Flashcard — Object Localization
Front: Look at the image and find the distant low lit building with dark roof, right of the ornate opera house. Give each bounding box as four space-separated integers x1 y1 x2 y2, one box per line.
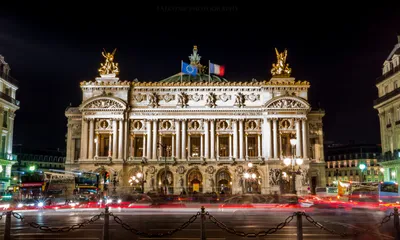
325 144 383 186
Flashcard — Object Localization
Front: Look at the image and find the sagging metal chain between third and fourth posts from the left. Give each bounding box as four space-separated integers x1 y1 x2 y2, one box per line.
206 212 297 237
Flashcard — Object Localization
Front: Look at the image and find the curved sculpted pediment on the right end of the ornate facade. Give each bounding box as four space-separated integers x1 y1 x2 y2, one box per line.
264 96 310 110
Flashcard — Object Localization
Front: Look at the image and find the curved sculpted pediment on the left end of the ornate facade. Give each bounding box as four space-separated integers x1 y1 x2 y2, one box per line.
80 97 126 111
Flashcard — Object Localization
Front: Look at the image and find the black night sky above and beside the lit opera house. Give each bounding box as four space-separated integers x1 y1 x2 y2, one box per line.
0 1 400 149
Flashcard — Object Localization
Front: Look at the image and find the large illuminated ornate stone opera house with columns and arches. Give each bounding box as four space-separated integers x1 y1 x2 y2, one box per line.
65 47 326 194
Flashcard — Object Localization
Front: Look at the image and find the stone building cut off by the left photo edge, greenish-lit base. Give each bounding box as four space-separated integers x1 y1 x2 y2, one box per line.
0 55 19 193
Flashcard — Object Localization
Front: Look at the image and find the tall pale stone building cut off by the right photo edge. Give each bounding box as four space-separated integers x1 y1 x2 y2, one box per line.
374 36 400 182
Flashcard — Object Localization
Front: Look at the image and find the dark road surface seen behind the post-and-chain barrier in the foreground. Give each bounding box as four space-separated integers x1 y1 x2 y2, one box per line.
0 208 394 240
